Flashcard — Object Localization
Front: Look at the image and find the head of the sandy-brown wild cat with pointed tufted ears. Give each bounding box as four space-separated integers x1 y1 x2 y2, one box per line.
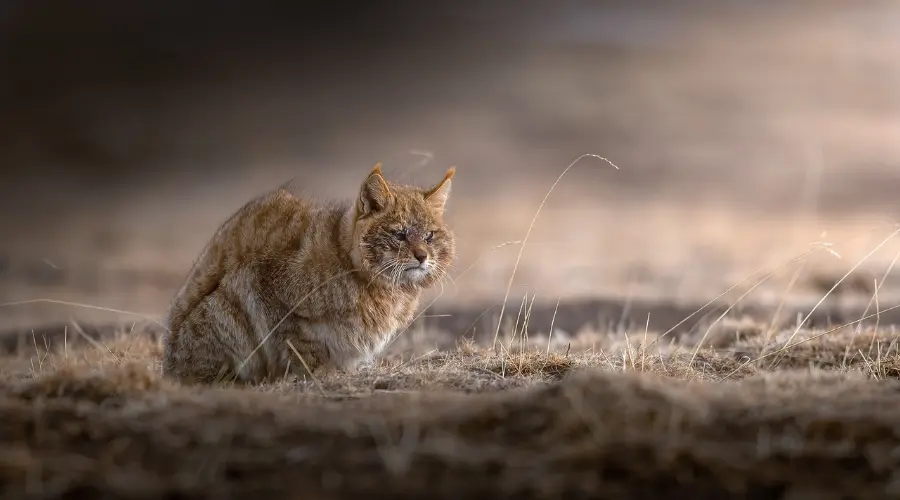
353 163 456 288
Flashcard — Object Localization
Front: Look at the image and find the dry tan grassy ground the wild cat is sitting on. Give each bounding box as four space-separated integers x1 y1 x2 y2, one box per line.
0 318 900 498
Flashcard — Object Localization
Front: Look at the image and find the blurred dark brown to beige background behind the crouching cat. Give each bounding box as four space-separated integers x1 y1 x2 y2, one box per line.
0 0 900 336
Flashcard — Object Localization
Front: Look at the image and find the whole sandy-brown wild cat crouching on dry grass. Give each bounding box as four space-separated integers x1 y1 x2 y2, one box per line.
162 163 455 384
